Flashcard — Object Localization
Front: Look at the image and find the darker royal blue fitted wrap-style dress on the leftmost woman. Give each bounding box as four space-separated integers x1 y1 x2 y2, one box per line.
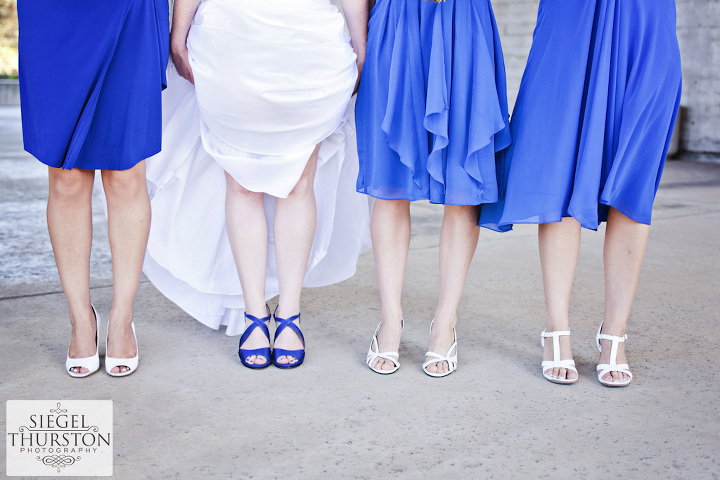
17 0 170 170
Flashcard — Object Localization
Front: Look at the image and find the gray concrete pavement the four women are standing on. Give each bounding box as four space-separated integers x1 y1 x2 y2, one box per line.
0 103 720 479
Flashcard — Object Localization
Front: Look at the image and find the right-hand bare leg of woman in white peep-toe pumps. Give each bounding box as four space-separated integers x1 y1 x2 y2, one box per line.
102 161 150 373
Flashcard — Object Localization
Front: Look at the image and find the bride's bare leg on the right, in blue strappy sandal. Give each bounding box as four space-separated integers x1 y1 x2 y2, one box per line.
274 144 320 364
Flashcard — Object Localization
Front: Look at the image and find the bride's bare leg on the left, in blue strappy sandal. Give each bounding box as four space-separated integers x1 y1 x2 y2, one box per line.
225 172 270 365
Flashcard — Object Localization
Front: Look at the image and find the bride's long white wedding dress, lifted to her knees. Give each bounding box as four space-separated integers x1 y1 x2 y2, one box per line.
143 0 370 335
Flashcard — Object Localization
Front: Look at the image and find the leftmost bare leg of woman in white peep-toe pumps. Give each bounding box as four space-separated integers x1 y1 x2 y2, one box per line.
47 167 96 373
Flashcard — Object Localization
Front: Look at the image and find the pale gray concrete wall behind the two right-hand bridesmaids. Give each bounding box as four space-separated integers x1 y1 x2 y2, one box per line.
493 0 720 155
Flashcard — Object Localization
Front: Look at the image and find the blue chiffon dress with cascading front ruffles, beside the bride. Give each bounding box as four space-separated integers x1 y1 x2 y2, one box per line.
356 0 510 205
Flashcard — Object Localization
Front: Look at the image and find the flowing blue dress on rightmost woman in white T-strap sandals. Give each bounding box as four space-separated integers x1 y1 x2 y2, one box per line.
480 0 682 231
